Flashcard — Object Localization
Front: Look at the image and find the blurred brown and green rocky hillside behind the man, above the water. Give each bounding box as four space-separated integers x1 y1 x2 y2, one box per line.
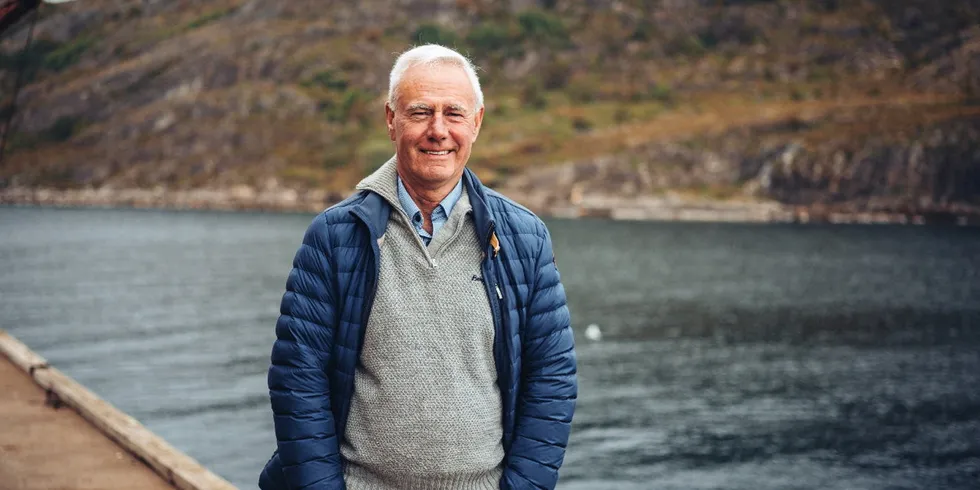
0 0 980 219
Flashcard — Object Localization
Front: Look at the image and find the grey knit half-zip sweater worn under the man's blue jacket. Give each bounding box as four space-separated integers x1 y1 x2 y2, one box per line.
341 160 504 490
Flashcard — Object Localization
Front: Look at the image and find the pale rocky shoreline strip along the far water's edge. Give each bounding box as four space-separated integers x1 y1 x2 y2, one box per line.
0 188 980 227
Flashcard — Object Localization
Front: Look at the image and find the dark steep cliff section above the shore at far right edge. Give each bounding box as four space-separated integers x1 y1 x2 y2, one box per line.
745 116 980 211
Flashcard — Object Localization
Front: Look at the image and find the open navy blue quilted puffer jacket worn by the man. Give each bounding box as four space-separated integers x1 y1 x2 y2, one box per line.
259 169 578 490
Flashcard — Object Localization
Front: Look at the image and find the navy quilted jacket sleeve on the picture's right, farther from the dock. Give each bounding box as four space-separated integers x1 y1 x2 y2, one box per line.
500 224 578 490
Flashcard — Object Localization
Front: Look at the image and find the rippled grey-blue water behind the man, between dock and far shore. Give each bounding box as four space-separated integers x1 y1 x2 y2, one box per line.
0 208 980 490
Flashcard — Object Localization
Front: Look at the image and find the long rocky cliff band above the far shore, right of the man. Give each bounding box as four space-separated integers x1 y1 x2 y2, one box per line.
506 112 980 215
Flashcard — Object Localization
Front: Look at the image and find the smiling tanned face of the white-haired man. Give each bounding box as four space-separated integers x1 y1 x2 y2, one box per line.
385 64 483 186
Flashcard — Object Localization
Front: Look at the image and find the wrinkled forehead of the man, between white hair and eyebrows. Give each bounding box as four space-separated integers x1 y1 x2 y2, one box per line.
395 62 477 111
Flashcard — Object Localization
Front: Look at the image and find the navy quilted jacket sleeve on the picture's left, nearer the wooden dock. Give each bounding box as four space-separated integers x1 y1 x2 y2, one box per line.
268 215 344 490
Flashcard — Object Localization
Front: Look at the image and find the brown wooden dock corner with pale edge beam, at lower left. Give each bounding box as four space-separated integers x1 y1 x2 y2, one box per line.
0 330 235 490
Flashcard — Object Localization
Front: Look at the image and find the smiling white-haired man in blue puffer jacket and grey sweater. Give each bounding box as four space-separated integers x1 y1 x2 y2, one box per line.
259 45 577 490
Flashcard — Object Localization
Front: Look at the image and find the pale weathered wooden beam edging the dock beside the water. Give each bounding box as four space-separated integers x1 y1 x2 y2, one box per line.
0 330 235 490
